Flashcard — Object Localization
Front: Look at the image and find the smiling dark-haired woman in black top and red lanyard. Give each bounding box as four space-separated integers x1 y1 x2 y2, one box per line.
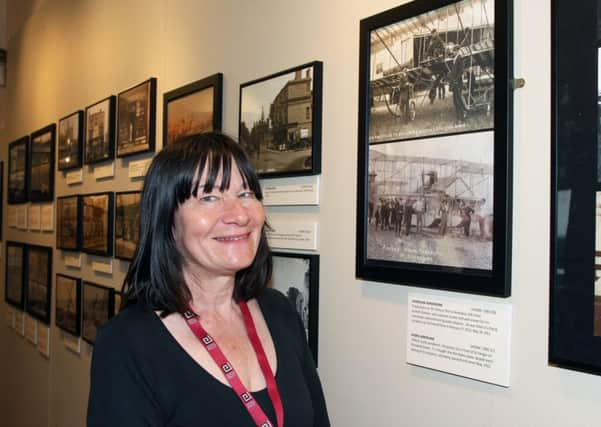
88 133 330 427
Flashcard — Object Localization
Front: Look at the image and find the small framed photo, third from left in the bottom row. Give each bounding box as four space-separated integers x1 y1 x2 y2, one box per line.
54 274 81 337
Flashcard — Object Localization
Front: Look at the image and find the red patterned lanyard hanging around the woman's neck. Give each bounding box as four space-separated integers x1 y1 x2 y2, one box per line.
184 301 284 427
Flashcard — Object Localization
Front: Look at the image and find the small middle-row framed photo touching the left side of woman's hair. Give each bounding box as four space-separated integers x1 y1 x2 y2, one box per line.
115 191 142 260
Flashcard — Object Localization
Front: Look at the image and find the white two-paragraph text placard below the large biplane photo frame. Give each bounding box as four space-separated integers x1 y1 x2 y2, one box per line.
407 293 511 387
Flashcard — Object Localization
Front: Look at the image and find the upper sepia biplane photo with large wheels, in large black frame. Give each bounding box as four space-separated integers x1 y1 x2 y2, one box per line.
369 0 495 143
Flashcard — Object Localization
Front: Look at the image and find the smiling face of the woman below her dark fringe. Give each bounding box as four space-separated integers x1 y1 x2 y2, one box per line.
173 162 265 279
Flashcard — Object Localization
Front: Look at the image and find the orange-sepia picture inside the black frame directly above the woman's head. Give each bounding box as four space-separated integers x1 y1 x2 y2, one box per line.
167 86 214 144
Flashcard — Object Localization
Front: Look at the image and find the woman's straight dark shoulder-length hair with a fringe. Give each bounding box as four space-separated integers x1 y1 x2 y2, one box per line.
123 132 272 316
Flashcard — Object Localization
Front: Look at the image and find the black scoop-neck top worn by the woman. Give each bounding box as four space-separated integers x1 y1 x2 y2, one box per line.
87 289 330 427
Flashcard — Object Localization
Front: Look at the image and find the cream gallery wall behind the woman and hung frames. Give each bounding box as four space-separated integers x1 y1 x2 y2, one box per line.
0 0 601 427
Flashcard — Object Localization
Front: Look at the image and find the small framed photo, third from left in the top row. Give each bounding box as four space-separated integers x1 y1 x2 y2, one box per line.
57 110 84 171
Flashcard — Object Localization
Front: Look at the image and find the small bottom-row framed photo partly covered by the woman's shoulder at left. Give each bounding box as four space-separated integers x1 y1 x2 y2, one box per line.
81 281 115 344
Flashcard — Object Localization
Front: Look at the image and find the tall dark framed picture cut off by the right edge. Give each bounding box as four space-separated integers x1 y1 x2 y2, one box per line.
549 0 601 375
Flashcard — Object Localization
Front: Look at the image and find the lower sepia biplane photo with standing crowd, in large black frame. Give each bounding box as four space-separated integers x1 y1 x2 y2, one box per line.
367 132 494 270
